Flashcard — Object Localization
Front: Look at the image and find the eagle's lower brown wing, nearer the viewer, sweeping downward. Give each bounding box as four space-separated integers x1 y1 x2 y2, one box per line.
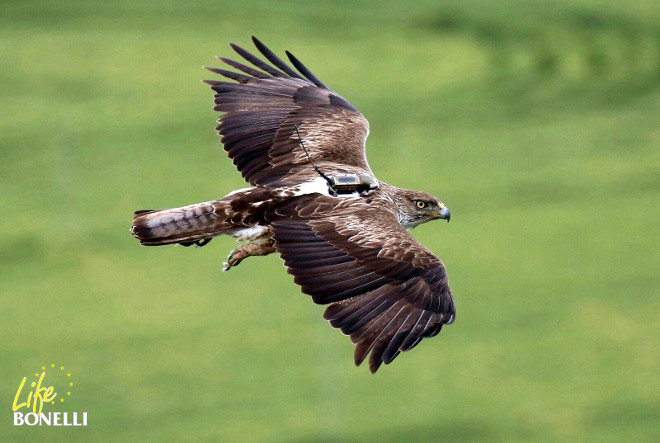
267 194 455 372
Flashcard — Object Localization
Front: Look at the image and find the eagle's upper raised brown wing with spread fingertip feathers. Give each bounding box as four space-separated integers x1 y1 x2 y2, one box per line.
205 37 371 186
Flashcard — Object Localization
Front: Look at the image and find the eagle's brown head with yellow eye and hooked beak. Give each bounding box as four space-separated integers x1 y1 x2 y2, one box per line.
394 189 449 229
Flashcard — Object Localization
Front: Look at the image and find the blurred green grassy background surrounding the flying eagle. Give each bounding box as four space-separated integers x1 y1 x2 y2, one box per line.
0 0 660 442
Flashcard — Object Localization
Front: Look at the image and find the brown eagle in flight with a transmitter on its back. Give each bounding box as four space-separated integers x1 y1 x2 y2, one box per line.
131 37 455 373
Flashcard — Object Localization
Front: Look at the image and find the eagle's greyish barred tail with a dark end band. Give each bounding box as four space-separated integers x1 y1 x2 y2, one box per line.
131 200 232 246
